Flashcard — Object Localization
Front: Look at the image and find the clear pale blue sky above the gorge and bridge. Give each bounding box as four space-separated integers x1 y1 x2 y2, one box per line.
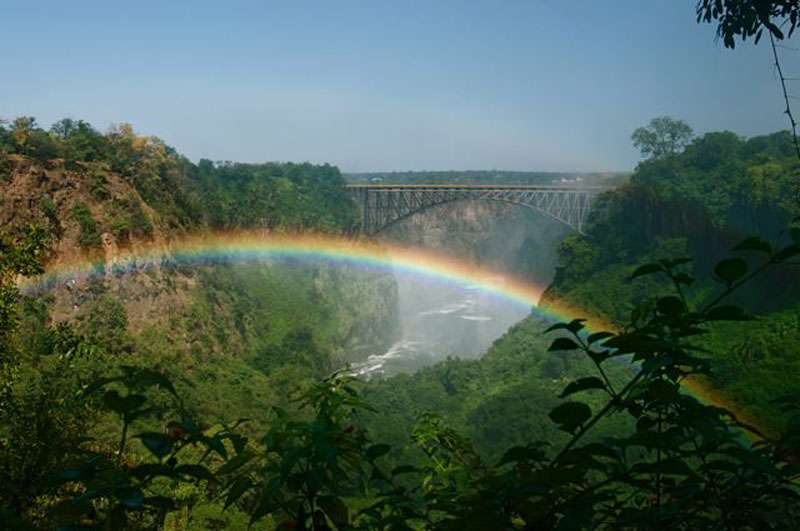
0 0 800 172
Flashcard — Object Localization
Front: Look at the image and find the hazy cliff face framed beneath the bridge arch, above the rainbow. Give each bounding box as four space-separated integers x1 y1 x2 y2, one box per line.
380 201 572 286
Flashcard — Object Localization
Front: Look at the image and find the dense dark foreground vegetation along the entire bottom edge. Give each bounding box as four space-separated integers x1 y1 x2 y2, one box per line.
0 213 800 529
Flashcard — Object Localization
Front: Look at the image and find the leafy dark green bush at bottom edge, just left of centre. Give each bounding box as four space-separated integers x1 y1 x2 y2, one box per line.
242 375 380 529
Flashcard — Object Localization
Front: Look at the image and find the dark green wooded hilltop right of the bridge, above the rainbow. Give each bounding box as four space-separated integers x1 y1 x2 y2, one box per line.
550 131 800 319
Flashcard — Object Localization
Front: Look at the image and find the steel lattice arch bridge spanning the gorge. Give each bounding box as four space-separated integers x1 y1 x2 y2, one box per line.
346 184 608 235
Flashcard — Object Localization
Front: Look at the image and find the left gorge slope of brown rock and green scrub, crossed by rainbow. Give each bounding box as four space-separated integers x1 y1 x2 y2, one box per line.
0 118 396 528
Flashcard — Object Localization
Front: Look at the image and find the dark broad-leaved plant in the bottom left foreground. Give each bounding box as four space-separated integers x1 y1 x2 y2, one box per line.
51 367 234 529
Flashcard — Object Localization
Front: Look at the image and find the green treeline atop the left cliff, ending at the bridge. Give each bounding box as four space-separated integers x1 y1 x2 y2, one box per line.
0 117 357 235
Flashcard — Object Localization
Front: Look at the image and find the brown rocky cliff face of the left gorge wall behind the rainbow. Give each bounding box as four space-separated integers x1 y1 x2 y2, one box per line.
0 157 397 372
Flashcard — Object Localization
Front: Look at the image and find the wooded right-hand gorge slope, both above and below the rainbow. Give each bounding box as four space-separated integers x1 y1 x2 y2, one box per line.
544 127 800 430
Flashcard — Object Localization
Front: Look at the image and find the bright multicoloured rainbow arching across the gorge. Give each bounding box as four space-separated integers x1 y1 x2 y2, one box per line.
20 231 758 440
